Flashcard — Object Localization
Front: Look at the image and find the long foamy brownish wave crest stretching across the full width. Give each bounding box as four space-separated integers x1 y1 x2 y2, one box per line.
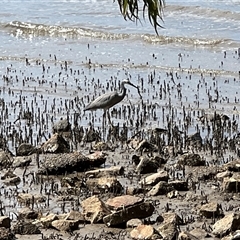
0 21 239 47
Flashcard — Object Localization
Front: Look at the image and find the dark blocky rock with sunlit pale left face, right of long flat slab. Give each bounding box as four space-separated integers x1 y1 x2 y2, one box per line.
136 156 159 174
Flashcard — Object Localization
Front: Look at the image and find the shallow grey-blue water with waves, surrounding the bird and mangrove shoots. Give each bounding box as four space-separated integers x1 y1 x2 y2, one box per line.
0 0 240 153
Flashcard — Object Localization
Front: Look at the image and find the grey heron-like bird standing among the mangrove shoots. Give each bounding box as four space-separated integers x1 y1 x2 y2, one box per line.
84 79 141 125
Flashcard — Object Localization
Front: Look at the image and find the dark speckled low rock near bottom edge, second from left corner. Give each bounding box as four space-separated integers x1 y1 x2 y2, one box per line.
13 221 41 235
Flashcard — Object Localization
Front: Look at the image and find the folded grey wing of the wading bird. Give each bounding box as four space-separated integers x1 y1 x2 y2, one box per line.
84 92 118 110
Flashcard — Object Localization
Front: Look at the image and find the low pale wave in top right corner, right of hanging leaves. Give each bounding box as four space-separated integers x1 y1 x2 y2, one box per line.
165 5 240 21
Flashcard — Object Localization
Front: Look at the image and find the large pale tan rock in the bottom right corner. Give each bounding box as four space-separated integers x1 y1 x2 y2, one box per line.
212 213 240 237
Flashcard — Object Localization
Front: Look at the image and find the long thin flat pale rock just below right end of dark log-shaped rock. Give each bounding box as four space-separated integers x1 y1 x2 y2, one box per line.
85 166 124 178
